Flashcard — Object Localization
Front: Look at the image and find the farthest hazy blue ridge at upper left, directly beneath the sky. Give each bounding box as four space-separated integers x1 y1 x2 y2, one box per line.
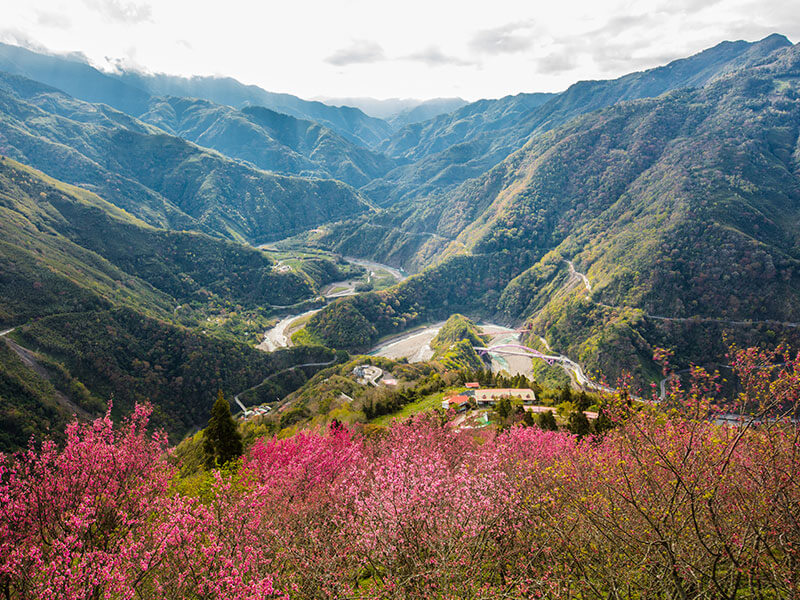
0 44 392 146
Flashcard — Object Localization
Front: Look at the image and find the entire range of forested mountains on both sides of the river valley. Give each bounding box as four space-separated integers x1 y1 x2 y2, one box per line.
0 35 800 444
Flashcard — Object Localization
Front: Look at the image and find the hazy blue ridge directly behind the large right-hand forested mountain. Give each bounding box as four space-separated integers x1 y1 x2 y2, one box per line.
364 35 791 206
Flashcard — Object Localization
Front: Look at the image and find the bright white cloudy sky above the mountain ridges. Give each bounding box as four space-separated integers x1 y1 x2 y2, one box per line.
0 0 800 100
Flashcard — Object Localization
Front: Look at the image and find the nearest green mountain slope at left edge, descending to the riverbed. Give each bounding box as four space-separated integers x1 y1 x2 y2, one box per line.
0 158 344 451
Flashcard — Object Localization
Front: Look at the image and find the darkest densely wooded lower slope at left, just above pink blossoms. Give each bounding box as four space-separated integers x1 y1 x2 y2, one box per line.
12 308 334 439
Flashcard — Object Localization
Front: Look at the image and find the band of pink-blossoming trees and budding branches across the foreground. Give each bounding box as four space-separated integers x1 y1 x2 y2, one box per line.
0 351 800 599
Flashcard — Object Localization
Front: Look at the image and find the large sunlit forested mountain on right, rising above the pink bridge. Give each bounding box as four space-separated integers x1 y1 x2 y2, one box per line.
309 38 800 383
